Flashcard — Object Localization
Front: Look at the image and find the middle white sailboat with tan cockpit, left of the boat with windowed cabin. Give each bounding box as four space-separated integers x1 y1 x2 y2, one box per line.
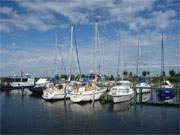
70 22 107 103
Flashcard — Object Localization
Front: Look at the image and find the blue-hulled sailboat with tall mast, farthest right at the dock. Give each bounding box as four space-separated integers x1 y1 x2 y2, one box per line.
158 33 176 97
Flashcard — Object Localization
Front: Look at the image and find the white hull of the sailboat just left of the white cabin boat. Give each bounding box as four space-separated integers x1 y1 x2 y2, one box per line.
70 88 106 103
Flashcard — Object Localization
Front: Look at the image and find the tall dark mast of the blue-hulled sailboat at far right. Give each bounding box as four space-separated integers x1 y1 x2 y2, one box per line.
161 33 165 82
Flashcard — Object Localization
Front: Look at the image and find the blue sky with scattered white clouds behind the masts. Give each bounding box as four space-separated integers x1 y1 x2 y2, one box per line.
0 0 180 76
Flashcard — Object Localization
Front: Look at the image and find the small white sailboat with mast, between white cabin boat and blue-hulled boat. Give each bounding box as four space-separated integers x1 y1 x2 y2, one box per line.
136 39 151 94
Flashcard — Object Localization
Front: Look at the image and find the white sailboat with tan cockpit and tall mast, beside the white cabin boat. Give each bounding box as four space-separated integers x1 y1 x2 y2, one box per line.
70 22 107 103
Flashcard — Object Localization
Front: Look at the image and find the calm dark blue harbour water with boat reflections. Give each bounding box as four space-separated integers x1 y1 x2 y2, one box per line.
0 91 180 134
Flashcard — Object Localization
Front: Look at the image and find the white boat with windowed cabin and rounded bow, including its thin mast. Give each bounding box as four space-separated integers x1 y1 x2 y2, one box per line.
108 35 134 103
